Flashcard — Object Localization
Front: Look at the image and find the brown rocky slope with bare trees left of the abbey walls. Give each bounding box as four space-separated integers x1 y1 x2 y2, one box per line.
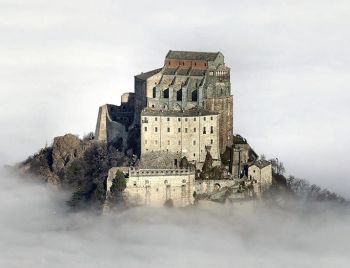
17 134 137 207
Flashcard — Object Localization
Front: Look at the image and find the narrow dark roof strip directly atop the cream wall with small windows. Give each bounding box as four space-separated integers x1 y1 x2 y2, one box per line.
141 108 218 117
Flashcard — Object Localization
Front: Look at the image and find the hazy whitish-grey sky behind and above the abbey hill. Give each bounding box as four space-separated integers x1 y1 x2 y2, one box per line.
0 0 350 196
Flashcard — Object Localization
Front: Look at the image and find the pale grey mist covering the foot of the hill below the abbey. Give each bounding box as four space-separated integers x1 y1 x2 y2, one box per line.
0 169 350 268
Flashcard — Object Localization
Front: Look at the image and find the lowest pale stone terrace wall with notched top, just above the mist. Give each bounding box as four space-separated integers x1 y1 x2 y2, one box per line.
123 169 195 207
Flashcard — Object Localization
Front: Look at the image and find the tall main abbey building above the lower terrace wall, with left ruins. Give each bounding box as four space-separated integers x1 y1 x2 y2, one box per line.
96 50 233 166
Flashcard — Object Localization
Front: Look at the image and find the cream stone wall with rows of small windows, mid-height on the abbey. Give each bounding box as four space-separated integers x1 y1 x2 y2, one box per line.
141 112 220 162
